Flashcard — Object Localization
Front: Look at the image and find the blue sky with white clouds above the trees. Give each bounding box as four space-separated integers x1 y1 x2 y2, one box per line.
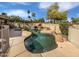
0 2 79 21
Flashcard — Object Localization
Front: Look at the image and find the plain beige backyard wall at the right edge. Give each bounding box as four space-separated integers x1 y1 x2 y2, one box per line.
68 27 79 47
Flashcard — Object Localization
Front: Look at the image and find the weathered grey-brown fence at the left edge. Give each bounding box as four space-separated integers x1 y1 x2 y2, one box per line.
0 25 9 52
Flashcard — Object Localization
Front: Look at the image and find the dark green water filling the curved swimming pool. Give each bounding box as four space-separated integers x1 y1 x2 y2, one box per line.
24 29 57 53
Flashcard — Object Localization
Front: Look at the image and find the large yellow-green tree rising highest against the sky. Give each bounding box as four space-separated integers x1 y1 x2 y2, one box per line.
47 3 67 23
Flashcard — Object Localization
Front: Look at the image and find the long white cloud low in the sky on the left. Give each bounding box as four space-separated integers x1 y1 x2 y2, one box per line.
7 9 28 18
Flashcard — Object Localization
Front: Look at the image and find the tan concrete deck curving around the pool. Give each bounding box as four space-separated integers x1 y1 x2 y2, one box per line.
7 31 79 57
